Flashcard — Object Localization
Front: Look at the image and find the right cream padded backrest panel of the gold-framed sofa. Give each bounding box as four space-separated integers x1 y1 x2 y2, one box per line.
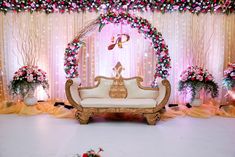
124 78 159 99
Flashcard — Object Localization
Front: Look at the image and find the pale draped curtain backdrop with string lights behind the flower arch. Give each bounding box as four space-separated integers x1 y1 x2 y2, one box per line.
0 12 235 103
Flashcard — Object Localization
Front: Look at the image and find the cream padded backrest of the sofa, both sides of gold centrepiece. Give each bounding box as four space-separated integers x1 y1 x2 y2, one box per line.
79 76 159 99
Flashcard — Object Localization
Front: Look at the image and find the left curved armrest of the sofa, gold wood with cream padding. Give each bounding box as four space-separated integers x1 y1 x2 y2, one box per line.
65 79 82 110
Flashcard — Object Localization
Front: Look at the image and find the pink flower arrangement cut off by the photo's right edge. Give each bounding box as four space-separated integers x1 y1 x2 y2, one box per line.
223 63 235 90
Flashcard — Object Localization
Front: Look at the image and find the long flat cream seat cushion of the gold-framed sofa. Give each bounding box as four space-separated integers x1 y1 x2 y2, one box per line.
81 98 157 108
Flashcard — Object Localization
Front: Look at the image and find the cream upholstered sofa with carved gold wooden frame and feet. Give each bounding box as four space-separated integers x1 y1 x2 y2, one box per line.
65 76 171 125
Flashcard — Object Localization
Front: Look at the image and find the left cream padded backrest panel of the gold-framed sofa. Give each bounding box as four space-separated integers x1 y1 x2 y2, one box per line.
79 78 113 99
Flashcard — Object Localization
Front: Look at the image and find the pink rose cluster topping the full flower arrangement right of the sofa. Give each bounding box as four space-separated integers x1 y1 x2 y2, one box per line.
180 66 214 82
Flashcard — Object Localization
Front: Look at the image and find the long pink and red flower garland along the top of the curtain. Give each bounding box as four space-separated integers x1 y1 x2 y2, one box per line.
0 0 235 14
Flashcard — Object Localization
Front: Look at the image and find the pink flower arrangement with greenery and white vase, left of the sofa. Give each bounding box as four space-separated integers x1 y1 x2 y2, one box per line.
9 66 49 105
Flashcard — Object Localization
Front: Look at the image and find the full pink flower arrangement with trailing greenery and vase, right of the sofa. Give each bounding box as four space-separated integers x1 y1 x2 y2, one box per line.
178 66 218 105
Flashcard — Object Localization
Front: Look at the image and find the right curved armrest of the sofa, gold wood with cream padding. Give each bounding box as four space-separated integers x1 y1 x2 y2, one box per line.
156 79 171 110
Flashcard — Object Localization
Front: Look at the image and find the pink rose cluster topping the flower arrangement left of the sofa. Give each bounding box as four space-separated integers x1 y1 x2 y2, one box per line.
13 66 47 83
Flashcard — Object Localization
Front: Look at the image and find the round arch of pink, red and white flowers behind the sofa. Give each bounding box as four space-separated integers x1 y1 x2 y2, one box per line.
64 12 171 84
